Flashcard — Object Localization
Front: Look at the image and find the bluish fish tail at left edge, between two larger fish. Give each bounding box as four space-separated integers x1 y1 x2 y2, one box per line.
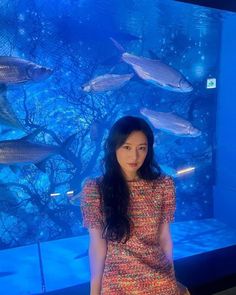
0 84 24 130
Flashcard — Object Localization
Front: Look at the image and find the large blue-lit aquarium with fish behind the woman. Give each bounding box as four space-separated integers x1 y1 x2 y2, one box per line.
0 0 236 295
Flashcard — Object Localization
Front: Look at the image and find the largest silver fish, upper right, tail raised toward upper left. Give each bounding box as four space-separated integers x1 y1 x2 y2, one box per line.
110 38 193 92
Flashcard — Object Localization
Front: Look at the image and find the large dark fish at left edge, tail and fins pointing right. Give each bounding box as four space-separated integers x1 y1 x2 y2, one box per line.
0 129 75 172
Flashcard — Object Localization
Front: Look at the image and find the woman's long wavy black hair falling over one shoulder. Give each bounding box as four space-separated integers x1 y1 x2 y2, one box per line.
98 116 160 243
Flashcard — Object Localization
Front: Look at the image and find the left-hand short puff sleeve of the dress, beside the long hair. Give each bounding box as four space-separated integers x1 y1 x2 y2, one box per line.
80 179 103 229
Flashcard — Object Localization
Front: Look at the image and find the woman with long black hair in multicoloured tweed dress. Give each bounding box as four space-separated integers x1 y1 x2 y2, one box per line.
81 116 189 295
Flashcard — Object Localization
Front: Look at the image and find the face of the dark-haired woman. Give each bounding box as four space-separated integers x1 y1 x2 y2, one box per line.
116 131 148 180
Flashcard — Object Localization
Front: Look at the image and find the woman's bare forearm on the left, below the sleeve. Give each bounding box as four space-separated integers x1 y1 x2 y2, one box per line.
89 228 107 295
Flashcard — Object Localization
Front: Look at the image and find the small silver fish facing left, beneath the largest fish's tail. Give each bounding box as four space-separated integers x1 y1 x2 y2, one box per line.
82 74 134 92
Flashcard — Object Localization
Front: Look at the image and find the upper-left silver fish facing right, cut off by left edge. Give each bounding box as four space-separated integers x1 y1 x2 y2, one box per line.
0 56 52 84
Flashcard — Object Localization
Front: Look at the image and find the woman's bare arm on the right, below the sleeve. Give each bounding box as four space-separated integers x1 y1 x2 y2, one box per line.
160 223 173 265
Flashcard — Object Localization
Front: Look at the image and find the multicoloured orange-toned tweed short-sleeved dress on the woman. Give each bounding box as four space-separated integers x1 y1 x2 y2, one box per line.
81 177 179 295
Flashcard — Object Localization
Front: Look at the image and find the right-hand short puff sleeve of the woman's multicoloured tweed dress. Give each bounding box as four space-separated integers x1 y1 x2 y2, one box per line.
161 177 176 223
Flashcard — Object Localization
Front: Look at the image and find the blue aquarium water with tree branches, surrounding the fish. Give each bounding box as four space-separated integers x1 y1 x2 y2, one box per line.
0 0 236 294
